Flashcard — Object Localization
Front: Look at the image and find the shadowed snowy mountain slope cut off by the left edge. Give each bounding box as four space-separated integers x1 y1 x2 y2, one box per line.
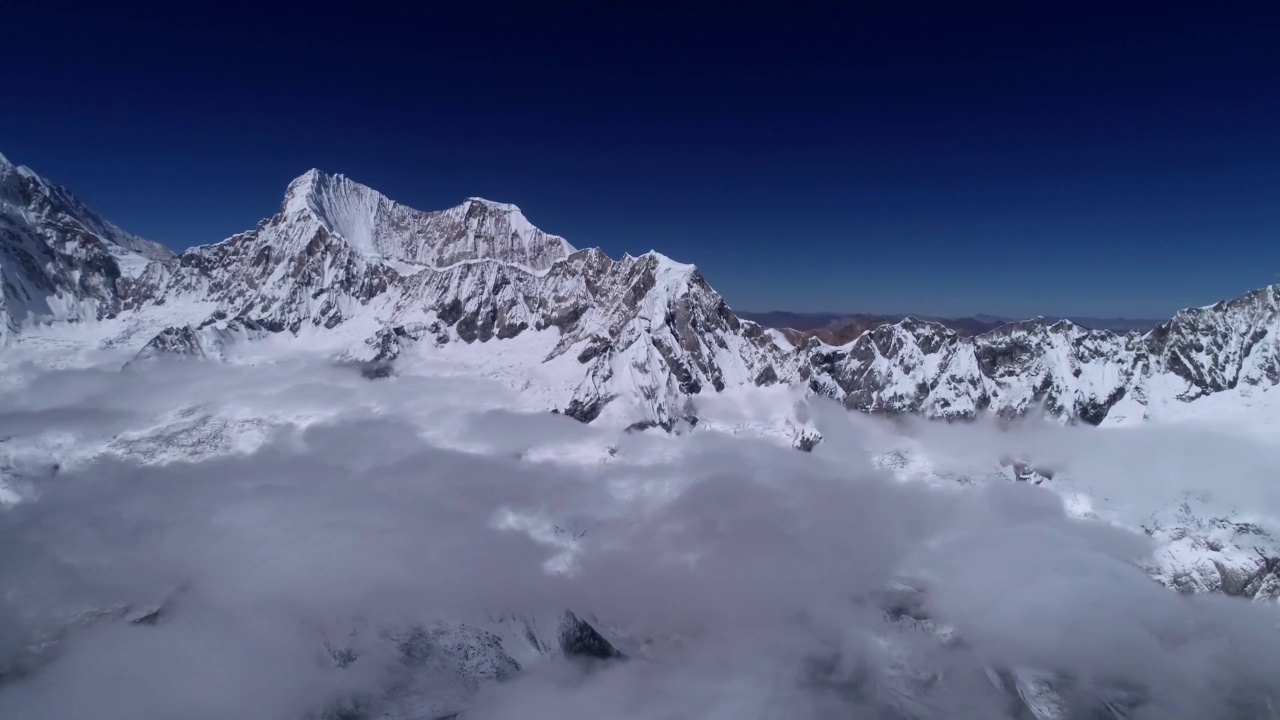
0 155 173 340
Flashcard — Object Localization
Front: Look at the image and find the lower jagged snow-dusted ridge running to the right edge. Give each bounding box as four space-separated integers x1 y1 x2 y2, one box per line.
801 286 1280 424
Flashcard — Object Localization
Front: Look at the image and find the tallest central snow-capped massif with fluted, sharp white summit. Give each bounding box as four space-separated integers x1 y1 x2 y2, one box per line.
104 163 795 427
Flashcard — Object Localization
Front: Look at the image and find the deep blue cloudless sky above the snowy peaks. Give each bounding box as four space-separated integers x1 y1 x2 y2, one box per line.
0 0 1280 316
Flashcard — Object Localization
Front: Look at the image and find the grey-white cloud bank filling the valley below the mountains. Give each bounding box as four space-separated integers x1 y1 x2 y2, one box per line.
0 361 1280 720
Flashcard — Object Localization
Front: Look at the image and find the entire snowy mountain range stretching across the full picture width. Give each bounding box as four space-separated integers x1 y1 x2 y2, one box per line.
0 149 1280 447
